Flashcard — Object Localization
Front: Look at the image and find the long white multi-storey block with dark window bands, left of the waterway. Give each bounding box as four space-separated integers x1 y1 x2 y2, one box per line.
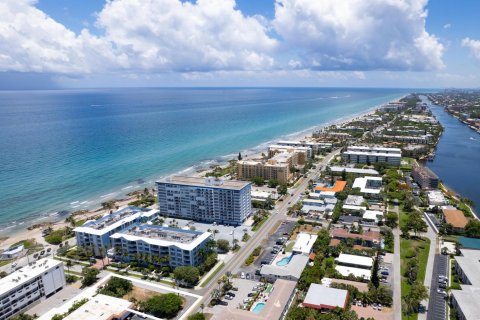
342 146 402 166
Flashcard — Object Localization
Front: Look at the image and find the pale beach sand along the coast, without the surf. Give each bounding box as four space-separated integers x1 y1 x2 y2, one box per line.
0 106 379 249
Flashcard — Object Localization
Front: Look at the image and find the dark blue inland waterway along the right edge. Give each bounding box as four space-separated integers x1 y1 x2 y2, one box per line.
424 100 480 216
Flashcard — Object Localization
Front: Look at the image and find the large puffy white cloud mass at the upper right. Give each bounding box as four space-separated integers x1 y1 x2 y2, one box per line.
273 0 444 70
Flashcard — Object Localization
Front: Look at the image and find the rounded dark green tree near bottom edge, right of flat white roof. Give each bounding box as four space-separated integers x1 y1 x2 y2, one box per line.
141 293 183 318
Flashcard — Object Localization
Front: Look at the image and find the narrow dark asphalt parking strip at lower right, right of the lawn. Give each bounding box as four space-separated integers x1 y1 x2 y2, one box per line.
427 254 448 320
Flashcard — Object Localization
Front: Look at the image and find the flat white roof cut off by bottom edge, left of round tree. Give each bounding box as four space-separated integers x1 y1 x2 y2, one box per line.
64 294 132 320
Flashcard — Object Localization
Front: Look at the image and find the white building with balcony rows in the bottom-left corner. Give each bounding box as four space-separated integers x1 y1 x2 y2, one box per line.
0 259 66 320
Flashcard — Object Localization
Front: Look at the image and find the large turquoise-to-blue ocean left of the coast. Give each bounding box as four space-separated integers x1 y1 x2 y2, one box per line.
0 88 409 232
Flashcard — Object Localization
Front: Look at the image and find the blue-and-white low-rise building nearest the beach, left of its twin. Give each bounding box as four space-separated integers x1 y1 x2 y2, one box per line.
73 206 158 256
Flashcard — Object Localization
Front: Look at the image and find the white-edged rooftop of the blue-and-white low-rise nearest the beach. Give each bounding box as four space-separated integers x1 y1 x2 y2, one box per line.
73 206 158 234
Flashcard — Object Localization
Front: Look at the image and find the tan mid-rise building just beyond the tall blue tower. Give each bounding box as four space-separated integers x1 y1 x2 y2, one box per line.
237 157 293 184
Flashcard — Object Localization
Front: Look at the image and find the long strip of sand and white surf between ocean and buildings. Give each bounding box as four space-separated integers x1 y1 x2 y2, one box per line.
0 95 400 248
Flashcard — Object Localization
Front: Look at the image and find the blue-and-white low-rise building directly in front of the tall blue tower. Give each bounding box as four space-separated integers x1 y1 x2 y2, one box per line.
109 224 212 268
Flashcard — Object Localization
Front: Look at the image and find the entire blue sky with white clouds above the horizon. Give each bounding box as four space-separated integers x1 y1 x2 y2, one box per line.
0 0 480 89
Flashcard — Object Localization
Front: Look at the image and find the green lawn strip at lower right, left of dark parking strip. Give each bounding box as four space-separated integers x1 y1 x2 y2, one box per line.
400 238 430 320
